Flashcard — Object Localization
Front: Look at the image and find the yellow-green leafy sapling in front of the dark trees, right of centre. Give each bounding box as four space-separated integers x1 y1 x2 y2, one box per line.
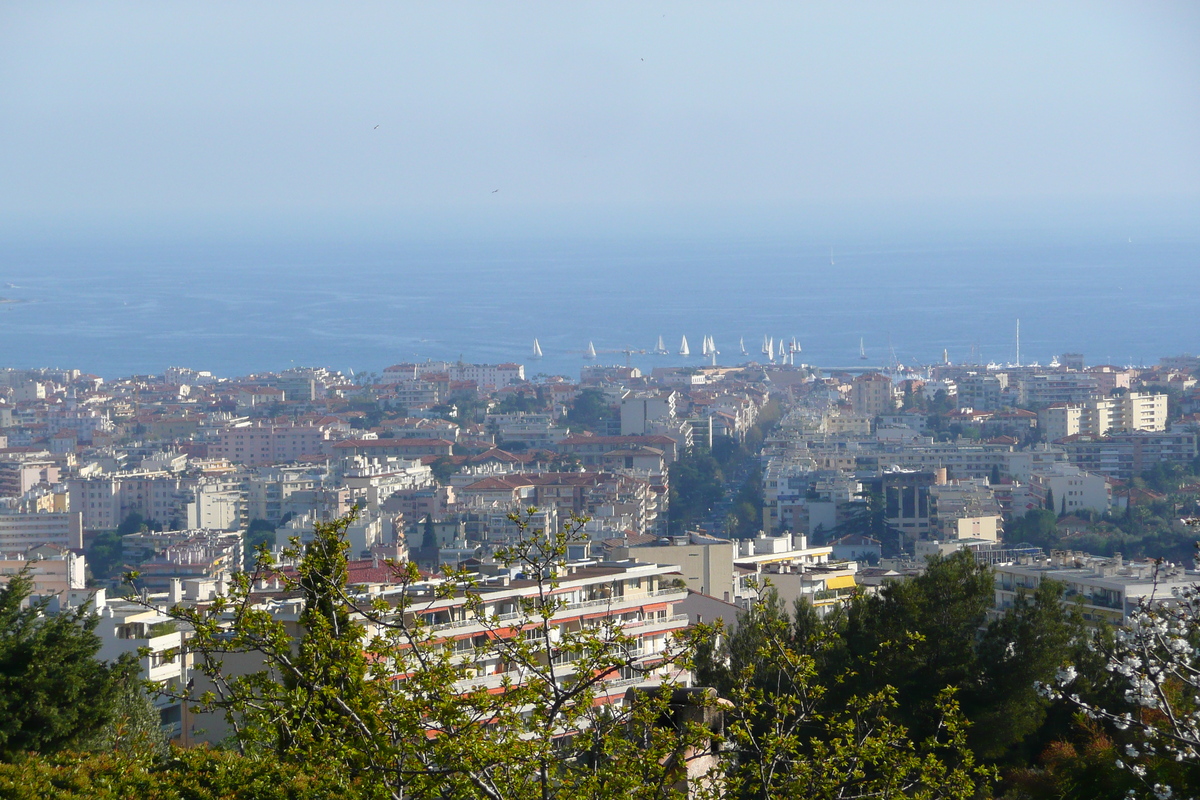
697 590 992 799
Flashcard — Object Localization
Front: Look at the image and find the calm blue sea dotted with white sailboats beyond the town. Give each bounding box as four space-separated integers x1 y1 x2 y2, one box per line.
0 231 1200 379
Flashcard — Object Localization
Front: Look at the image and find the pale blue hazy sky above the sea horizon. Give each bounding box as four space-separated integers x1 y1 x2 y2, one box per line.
0 0 1200 237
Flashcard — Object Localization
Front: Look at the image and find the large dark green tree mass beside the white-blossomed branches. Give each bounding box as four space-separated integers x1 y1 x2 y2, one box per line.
697 553 1152 798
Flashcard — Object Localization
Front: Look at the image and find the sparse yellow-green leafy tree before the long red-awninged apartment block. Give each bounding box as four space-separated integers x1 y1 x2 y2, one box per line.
166 512 700 800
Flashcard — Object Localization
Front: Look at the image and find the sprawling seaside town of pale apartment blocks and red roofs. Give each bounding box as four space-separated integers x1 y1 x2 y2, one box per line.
0 339 1200 762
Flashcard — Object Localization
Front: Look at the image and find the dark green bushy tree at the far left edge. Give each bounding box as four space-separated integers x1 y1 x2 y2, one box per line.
0 571 137 760
